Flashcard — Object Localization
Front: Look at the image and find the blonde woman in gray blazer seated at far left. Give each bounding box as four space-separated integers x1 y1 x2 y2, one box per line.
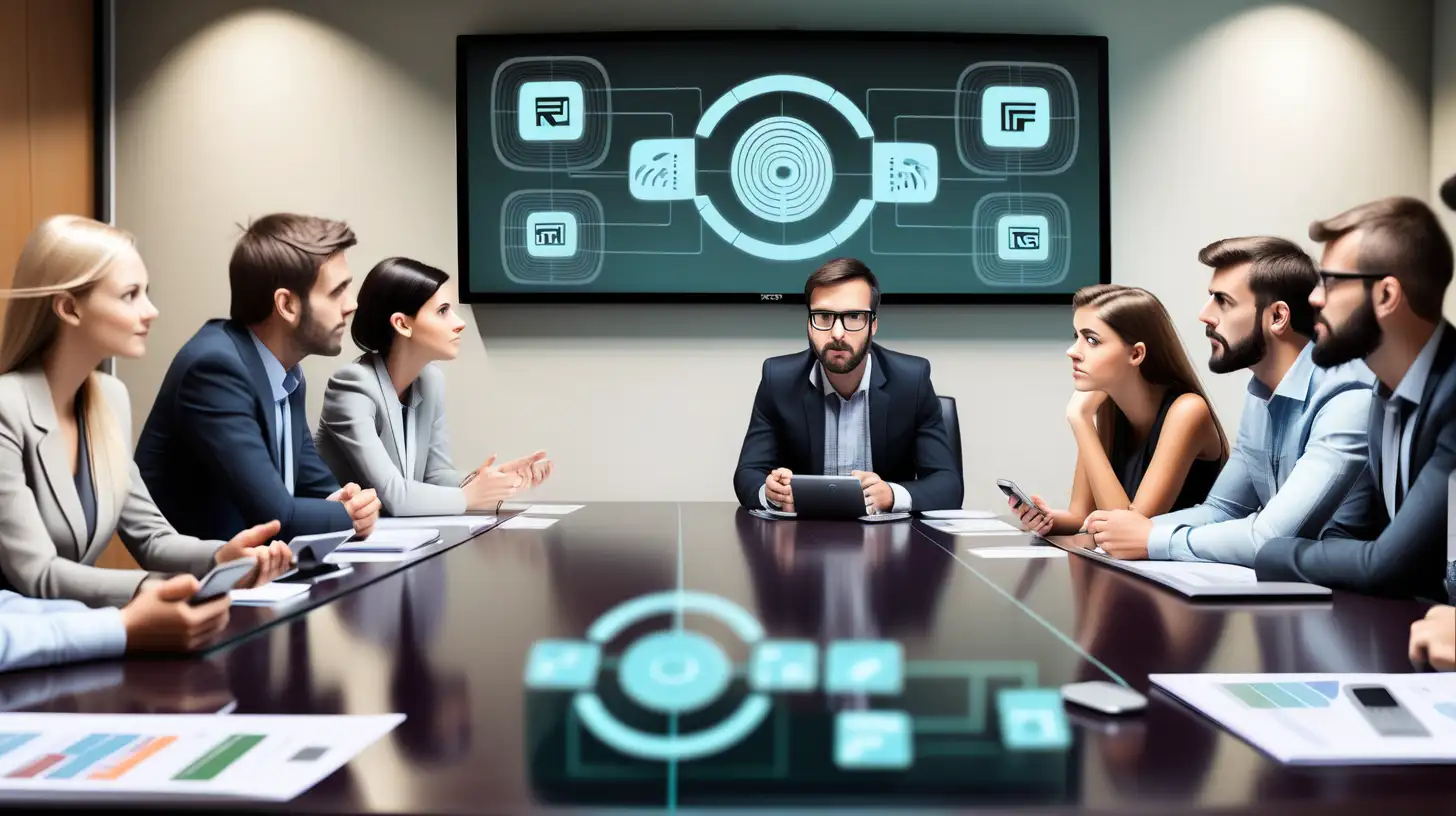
0 216 293 606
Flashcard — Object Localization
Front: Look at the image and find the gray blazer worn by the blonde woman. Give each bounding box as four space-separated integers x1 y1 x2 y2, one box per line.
0 366 223 606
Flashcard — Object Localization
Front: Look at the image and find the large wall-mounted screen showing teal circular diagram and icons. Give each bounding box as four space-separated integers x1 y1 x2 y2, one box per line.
460 36 1107 300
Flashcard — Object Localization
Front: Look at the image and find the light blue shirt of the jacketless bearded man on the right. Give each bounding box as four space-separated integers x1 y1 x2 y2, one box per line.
1147 342 1377 567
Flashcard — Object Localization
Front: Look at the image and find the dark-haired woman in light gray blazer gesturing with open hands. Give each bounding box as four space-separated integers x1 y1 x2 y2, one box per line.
314 258 552 516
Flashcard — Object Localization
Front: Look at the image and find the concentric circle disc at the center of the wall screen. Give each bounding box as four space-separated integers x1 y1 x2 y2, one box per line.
729 117 834 224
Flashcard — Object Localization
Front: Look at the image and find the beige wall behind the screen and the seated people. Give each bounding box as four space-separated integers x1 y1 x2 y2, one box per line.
116 0 1432 507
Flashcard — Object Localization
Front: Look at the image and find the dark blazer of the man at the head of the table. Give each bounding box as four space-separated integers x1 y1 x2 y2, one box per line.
732 342 965 510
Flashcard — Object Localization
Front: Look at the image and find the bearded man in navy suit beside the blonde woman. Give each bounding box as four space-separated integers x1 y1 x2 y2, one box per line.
137 213 380 541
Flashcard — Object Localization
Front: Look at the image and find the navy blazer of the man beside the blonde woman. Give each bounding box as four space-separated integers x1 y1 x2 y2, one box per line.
137 321 354 541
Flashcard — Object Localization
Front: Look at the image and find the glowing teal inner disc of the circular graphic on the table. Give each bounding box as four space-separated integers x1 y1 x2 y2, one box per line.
619 631 732 714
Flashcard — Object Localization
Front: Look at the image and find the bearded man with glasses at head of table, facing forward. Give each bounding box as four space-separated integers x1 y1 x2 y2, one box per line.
732 258 965 513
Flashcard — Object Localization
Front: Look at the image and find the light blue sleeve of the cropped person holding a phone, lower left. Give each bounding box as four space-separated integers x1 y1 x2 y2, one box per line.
0 590 127 672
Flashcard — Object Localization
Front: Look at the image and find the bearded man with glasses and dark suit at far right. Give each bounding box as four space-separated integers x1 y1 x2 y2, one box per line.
1255 197 1456 600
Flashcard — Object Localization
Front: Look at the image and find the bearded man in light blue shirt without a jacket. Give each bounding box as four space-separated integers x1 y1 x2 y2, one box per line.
1086 236 1374 567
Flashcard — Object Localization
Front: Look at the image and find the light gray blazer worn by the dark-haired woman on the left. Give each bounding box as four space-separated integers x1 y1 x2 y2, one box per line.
313 353 466 516
